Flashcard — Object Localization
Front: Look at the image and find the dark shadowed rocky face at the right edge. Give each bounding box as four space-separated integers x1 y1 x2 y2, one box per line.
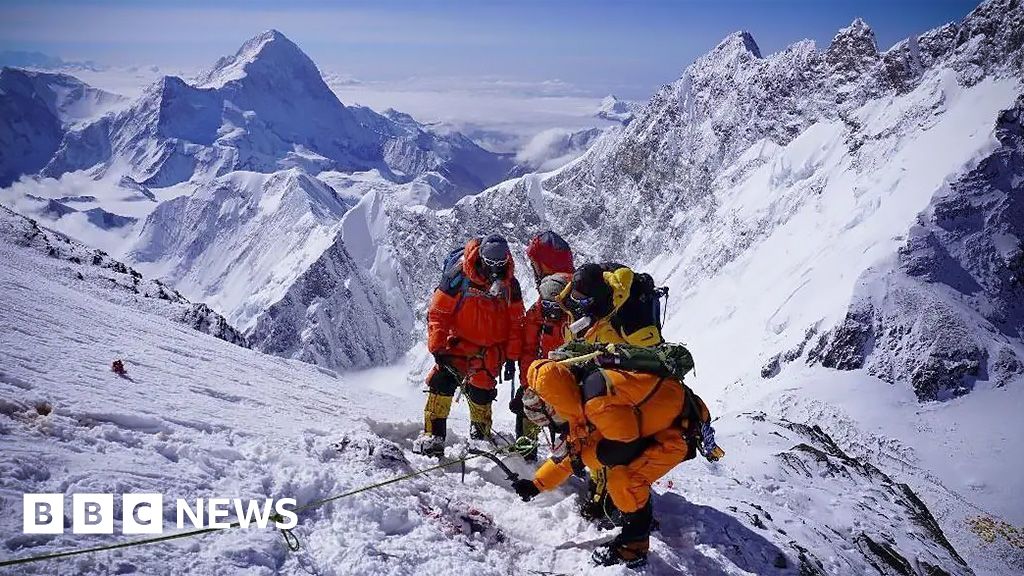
810 97 1024 400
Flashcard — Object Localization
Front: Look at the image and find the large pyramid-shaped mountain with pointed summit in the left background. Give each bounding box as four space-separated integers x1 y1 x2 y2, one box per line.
43 30 511 200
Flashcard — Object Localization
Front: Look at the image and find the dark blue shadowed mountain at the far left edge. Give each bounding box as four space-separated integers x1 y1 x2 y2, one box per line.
0 68 122 188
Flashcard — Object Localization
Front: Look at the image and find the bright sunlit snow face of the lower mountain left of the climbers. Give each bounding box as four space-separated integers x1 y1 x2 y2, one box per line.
128 169 349 330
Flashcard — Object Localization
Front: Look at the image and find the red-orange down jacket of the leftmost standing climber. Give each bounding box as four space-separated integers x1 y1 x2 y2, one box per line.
427 239 523 390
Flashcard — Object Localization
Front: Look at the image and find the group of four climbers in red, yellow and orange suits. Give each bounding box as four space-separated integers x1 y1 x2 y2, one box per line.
414 227 723 567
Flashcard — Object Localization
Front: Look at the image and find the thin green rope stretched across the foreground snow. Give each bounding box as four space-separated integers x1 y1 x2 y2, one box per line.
0 444 532 568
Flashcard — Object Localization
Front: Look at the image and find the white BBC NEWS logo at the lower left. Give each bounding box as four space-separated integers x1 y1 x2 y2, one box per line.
23 494 299 534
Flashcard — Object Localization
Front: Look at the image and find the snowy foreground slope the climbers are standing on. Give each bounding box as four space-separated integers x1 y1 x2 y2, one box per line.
0 226 1022 575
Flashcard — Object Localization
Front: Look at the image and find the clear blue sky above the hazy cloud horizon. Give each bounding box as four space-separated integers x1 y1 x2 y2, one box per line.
0 0 976 97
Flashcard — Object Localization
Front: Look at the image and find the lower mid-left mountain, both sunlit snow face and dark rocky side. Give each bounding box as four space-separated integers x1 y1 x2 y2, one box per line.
127 168 415 369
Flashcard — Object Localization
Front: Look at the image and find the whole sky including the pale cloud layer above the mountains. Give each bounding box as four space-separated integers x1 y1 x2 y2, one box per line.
0 0 976 152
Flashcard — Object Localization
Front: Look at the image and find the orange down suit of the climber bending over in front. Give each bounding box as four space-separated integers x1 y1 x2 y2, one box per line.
527 360 710 512
